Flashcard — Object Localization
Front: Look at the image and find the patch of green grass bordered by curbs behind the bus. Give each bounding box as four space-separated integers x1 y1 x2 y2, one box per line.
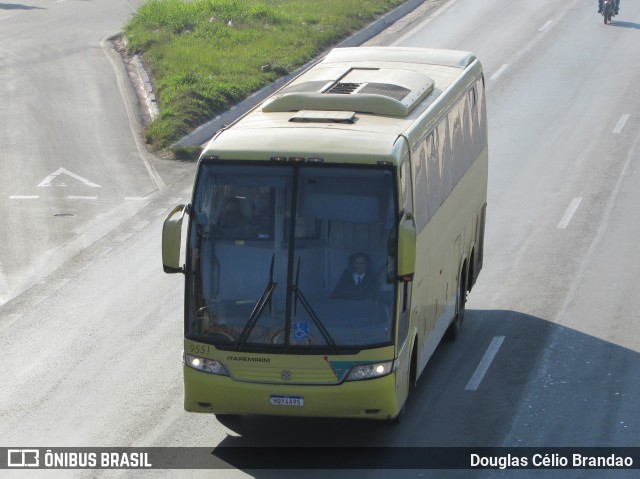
124 0 403 149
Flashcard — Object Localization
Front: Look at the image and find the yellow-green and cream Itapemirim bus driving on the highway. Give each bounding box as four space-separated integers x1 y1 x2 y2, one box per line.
162 47 488 421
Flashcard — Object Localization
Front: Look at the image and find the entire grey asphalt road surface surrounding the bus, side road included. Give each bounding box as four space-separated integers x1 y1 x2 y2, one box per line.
0 0 640 479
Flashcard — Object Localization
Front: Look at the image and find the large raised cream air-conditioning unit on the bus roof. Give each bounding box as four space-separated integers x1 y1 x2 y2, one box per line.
262 68 434 116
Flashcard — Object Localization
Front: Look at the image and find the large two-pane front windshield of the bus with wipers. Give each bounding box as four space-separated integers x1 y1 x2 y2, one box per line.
185 162 397 353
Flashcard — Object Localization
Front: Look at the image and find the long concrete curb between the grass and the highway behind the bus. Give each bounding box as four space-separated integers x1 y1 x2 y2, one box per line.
172 0 426 148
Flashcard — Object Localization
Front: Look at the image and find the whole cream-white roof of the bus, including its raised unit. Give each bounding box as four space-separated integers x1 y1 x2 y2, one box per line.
201 47 481 163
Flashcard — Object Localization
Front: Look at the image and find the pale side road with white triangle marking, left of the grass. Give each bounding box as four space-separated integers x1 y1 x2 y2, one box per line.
0 0 189 304
